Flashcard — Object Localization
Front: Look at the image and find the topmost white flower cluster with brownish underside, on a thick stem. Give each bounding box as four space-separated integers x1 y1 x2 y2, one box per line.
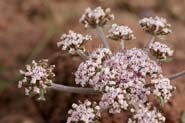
80 7 114 28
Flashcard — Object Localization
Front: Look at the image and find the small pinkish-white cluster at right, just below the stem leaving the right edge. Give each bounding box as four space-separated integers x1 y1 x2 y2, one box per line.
151 75 175 103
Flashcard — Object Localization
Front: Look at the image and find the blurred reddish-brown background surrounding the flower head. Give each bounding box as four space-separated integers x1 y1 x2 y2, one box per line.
0 0 185 123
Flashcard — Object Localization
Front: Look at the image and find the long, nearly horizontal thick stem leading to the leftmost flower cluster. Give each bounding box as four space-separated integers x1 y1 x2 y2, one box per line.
50 83 98 94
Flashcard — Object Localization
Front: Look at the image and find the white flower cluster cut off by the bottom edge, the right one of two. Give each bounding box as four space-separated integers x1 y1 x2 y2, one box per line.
128 106 166 123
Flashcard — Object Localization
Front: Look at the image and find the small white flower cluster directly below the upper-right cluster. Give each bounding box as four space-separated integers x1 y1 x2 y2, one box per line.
149 42 174 59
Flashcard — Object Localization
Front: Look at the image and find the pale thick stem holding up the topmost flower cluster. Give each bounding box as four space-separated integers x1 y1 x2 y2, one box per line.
96 26 110 49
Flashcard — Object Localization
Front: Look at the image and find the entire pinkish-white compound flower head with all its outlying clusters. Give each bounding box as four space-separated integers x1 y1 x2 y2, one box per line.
19 7 175 123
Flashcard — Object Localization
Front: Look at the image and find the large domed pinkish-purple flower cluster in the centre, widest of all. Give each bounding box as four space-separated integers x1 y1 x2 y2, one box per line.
96 48 161 91
